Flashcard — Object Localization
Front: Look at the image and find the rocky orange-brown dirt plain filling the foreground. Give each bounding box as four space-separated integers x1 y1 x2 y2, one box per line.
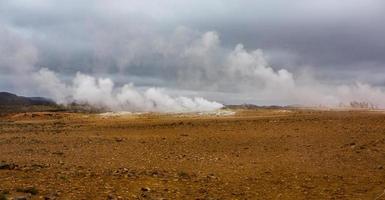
0 109 385 200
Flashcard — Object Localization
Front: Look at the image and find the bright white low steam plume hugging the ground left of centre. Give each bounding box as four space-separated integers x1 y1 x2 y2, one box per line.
33 68 223 112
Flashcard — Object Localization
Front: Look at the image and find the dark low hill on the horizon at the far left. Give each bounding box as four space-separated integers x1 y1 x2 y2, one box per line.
0 92 56 107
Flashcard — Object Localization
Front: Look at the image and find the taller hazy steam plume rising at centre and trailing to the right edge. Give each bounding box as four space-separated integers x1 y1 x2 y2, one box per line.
146 28 385 108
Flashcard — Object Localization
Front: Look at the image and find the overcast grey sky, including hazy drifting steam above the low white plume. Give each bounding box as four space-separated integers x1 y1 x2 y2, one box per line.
0 0 385 109
